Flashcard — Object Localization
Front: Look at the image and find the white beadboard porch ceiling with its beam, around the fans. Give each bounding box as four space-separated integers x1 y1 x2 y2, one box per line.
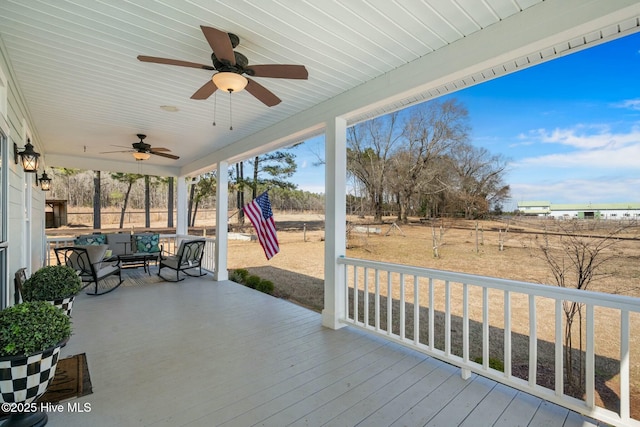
0 0 640 175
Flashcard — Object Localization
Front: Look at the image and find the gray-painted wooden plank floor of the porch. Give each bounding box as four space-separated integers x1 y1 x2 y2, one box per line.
49 271 597 427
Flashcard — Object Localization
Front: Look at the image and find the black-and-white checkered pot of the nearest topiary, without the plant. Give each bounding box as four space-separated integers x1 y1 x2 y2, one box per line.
0 344 61 403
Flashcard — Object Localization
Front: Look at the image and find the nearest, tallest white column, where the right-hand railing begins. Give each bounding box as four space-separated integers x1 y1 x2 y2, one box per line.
322 117 347 329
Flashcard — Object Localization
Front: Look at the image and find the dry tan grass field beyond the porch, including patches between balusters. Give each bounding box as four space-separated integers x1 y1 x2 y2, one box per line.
229 214 640 418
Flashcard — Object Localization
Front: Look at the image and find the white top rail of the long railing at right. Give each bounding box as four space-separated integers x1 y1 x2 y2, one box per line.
337 256 640 313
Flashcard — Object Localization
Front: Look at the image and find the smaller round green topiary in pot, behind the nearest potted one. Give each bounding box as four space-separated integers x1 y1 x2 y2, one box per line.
22 265 82 315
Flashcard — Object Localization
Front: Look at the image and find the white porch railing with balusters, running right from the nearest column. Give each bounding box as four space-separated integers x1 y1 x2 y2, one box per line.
337 257 640 426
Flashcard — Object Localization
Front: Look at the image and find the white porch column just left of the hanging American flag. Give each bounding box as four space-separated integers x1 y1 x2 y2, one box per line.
213 162 229 281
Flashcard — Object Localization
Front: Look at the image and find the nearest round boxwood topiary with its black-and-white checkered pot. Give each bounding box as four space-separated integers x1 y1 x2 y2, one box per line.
0 301 71 427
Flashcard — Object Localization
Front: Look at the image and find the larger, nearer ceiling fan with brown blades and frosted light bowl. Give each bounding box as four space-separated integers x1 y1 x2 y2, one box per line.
138 25 309 107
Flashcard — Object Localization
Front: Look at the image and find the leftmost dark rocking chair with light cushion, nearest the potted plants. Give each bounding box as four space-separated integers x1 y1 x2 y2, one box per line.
54 245 123 295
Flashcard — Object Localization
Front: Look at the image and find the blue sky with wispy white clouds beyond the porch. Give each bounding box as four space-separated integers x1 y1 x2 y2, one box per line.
294 34 640 209
